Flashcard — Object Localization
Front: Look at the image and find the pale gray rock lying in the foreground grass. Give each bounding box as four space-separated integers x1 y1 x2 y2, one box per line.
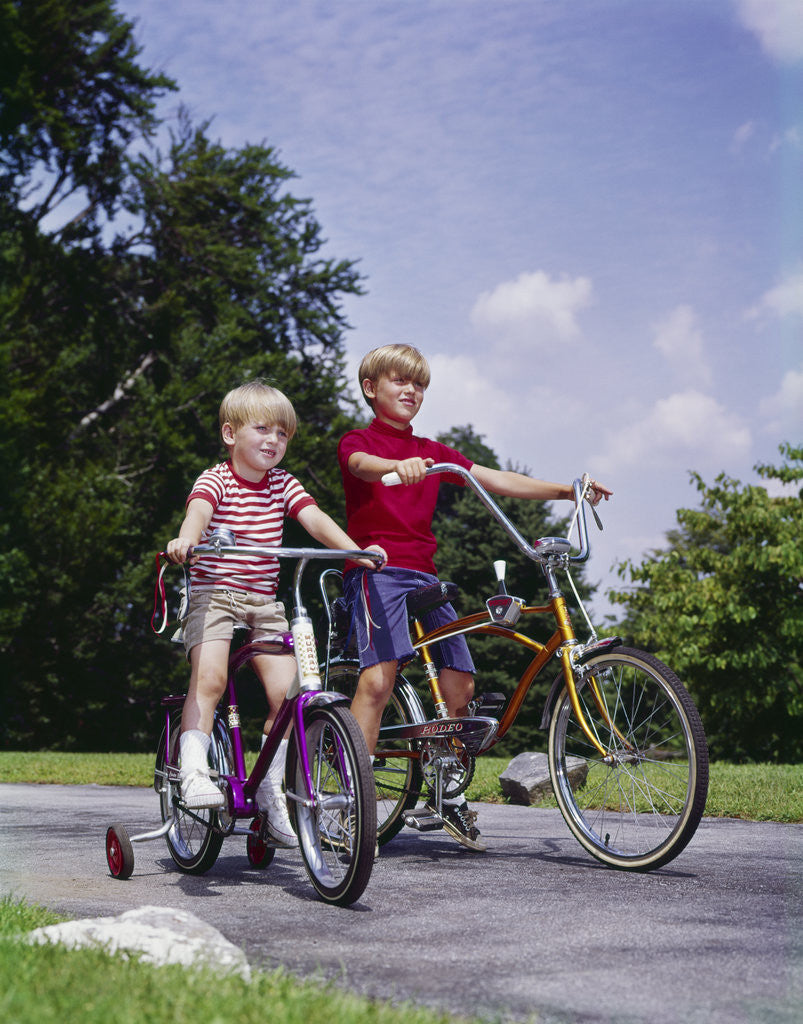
26 906 250 979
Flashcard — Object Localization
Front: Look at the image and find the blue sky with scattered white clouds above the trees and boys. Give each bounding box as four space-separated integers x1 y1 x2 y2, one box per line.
117 0 803 621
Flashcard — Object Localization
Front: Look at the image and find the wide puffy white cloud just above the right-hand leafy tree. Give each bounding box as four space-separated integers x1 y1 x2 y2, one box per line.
594 390 751 473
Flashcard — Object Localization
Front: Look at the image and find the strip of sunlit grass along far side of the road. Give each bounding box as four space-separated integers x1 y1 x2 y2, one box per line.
0 751 803 821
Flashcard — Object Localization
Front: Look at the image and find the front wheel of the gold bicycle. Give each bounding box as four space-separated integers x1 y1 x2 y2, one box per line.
549 647 708 871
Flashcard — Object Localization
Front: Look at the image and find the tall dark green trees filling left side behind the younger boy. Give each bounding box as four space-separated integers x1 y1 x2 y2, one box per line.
0 0 360 750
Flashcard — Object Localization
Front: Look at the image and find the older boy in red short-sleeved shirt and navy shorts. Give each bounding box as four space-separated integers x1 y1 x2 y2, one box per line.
338 345 611 851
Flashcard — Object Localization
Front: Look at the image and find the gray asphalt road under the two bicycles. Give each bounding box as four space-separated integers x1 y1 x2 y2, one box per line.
0 784 803 1024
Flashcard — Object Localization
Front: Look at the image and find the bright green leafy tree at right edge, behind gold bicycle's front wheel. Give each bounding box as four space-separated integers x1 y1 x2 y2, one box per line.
611 444 803 762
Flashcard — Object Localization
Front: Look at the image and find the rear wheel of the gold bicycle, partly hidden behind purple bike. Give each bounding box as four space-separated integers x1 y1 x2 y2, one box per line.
327 662 423 846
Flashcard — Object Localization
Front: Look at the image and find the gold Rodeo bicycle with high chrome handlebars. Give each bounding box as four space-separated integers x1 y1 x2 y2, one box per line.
321 464 709 871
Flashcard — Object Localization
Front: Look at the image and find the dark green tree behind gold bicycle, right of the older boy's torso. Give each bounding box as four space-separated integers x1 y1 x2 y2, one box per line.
413 427 590 756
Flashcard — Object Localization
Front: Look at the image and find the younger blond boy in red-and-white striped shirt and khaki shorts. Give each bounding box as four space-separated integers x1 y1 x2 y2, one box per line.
167 380 384 847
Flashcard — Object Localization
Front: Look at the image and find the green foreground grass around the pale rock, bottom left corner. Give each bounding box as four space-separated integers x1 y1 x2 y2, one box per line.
0 897 465 1024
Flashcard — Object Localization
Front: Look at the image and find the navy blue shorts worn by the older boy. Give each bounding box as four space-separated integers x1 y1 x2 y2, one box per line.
343 566 474 675
